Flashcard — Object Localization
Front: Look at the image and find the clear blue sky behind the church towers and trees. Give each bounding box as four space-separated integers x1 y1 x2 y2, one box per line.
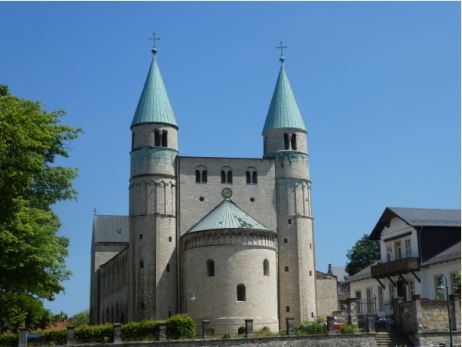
0 2 460 314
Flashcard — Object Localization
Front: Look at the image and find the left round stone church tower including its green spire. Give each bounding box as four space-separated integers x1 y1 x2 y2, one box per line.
128 41 178 321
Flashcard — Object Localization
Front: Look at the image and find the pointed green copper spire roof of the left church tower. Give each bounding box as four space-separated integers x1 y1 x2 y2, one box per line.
132 57 177 126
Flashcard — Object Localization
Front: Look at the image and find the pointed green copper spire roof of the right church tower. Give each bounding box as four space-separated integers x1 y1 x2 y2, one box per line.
263 65 306 132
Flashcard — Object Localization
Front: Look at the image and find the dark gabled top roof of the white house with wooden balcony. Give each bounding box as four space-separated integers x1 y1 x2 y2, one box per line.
369 207 460 240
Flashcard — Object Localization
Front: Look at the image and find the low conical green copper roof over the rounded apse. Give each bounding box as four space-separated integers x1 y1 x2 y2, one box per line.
188 199 268 233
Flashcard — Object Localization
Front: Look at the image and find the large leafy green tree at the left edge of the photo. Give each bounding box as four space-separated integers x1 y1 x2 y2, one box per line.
0 86 81 327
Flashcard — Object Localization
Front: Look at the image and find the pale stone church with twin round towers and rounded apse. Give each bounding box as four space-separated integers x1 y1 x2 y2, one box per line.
90 40 322 335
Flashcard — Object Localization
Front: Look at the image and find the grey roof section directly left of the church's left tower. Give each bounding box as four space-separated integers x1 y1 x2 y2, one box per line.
93 215 128 243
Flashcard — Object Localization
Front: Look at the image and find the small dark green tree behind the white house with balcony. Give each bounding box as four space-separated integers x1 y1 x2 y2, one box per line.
345 234 380 276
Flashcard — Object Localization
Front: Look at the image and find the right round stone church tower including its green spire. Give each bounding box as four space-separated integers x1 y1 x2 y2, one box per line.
263 54 316 328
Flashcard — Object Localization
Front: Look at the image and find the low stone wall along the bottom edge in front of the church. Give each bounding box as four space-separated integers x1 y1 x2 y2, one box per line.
70 334 377 347
